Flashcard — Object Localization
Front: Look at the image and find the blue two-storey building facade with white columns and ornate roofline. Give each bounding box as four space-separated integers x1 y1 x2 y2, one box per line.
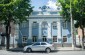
17 6 72 46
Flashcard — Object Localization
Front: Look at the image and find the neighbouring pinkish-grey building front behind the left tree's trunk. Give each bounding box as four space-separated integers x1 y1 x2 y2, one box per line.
0 22 19 46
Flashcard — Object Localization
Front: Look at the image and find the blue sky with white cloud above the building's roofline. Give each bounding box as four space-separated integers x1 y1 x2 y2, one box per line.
31 0 57 10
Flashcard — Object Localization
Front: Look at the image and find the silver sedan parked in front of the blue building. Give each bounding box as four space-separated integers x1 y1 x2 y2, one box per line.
23 42 54 53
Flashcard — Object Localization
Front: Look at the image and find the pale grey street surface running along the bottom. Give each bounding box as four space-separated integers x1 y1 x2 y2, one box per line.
0 50 85 55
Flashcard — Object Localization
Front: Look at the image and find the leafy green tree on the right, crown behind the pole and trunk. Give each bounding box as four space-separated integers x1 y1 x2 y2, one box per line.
59 0 85 49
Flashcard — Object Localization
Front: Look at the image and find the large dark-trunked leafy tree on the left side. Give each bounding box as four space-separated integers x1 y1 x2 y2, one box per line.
0 0 33 50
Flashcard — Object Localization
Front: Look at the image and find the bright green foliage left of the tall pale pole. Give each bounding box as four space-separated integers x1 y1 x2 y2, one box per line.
58 0 70 20
